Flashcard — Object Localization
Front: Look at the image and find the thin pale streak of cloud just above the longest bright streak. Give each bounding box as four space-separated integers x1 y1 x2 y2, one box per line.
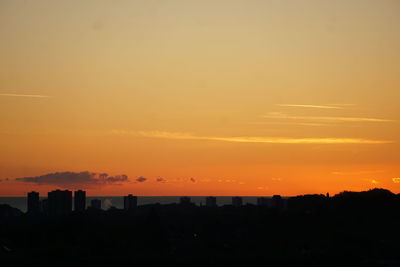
263 112 394 122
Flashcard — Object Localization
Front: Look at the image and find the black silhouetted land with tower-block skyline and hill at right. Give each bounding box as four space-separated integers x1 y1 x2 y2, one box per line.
0 189 400 266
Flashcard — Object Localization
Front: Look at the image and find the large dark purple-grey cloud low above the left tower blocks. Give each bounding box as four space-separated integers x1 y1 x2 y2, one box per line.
15 171 129 188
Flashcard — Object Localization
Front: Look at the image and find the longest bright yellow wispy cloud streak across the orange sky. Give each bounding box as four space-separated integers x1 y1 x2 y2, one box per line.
112 130 393 144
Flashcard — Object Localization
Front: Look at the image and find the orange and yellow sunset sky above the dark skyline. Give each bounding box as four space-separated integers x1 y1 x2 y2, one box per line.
0 0 400 196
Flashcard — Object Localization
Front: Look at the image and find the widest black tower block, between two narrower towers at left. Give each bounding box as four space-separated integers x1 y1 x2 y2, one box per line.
48 190 72 216
